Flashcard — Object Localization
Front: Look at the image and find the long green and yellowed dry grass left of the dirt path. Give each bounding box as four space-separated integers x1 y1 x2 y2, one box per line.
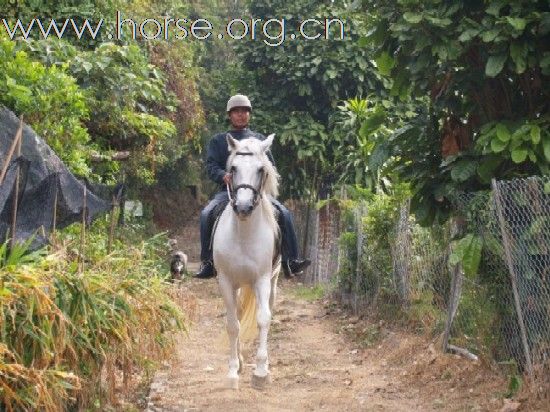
0 230 185 411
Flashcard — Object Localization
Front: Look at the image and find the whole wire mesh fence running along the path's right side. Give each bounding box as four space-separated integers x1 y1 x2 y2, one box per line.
293 176 550 391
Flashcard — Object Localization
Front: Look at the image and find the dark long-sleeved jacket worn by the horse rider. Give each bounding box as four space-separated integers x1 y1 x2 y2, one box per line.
206 128 275 190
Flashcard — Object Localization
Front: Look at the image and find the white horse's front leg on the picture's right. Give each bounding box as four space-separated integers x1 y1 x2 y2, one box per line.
252 273 271 387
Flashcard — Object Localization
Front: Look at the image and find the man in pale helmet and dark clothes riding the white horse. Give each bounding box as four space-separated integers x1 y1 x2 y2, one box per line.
195 94 311 279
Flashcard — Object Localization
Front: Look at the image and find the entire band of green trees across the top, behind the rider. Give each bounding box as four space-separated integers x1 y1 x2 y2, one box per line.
0 0 550 223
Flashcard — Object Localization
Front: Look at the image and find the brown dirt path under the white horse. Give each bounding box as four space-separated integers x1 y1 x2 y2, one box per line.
147 279 520 412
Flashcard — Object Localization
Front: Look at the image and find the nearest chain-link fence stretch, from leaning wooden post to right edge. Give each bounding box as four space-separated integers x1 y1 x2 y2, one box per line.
448 176 550 396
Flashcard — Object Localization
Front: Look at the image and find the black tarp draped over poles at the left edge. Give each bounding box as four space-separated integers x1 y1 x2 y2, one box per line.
0 106 111 249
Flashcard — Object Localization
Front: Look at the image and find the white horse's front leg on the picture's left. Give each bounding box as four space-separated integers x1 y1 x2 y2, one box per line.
218 273 240 389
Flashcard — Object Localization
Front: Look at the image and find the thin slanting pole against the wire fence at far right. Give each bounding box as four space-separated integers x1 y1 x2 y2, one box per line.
491 179 533 376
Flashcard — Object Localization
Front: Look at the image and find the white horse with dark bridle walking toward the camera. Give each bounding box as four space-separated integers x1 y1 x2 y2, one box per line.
213 134 281 389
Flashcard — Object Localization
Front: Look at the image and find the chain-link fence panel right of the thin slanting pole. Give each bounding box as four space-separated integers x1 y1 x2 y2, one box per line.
493 176 550 382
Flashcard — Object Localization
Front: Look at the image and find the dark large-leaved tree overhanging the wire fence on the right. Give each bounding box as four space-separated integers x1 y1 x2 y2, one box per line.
354 0 550 223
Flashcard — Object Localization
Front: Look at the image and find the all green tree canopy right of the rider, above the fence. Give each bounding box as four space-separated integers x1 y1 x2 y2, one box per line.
237 0 550 223
